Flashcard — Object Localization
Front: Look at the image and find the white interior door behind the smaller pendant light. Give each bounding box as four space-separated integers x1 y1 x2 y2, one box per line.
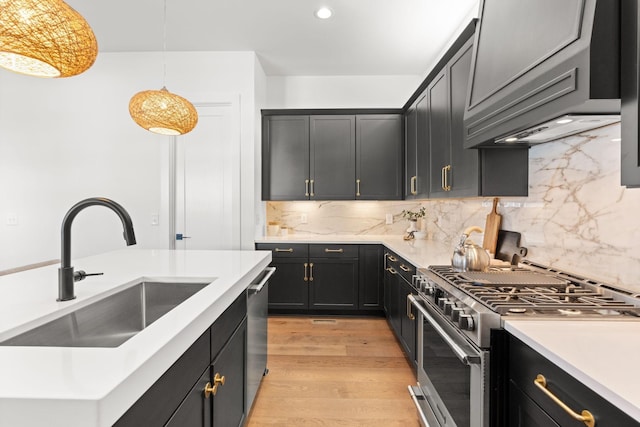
174 101 240 249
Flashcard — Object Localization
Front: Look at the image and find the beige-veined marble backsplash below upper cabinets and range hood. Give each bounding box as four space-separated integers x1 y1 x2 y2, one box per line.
266 124 640 292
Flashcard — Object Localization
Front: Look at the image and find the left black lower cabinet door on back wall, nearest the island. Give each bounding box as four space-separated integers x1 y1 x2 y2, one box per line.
269 258 310 310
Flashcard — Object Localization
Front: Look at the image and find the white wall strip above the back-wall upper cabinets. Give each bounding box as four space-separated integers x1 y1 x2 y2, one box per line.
265 75 423 109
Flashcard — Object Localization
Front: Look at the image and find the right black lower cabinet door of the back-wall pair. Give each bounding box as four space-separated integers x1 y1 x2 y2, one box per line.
309 258 358 310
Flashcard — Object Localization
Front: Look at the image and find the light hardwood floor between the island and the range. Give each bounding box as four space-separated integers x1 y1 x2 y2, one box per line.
247 316 419 427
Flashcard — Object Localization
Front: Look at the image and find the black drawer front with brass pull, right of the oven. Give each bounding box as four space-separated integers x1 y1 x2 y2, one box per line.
509 336 640 427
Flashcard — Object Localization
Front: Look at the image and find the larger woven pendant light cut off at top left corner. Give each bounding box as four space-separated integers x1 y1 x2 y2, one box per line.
0 0 98 77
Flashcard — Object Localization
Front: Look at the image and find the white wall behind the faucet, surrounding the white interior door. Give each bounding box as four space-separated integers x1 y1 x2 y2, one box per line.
0 52 256 270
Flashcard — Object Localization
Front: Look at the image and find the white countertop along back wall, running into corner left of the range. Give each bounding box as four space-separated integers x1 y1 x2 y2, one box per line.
256 234 453 268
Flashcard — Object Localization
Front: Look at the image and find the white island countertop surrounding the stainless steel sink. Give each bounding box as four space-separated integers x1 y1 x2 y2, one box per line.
0 249 271 427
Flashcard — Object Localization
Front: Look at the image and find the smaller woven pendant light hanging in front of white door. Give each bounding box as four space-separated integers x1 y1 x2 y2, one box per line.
129 87 198 135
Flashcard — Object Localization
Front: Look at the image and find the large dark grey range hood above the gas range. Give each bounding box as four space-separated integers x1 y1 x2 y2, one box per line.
464 0 620 148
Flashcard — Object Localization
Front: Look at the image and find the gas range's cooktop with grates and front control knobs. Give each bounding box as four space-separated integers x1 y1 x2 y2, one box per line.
416 260 640 348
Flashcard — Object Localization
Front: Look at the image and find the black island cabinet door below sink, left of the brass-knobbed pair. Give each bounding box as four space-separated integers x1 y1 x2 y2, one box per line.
165 368 211 427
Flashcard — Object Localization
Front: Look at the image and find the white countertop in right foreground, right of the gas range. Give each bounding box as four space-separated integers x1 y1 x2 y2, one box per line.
504 319 640 421
